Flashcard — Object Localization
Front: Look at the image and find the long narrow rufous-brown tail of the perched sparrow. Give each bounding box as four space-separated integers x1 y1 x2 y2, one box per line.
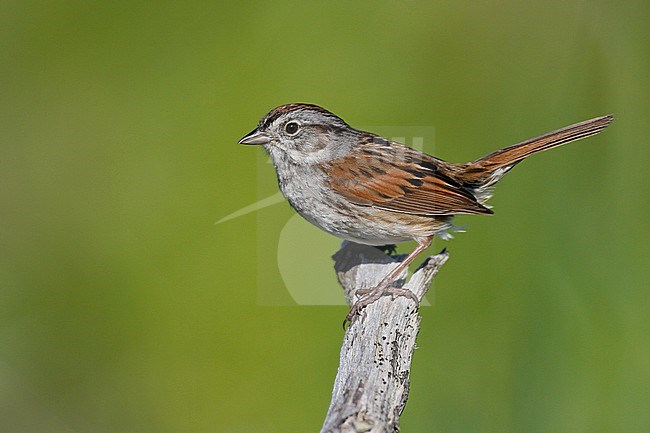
463 115 614 203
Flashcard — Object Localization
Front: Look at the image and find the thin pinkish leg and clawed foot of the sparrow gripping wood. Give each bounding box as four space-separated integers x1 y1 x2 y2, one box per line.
345 236 433 322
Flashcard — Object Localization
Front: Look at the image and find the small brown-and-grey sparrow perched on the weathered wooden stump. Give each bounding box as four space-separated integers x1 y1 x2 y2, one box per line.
239 104 613 320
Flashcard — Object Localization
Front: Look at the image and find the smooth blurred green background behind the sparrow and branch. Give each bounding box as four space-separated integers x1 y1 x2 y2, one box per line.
0 1 650 432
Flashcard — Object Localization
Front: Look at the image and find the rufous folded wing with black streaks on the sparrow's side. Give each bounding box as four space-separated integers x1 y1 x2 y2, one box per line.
325 134 493 216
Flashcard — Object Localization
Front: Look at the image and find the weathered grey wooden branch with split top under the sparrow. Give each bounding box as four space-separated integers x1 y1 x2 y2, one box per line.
321 242 449 433
